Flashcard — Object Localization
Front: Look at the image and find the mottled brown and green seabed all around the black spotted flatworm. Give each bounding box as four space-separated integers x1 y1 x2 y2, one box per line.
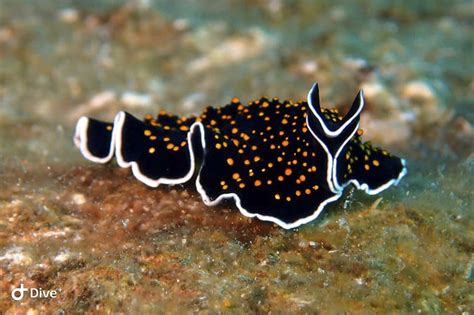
0 0 474 314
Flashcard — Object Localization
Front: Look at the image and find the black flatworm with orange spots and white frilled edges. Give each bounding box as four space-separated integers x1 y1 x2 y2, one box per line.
74 84 407 229
